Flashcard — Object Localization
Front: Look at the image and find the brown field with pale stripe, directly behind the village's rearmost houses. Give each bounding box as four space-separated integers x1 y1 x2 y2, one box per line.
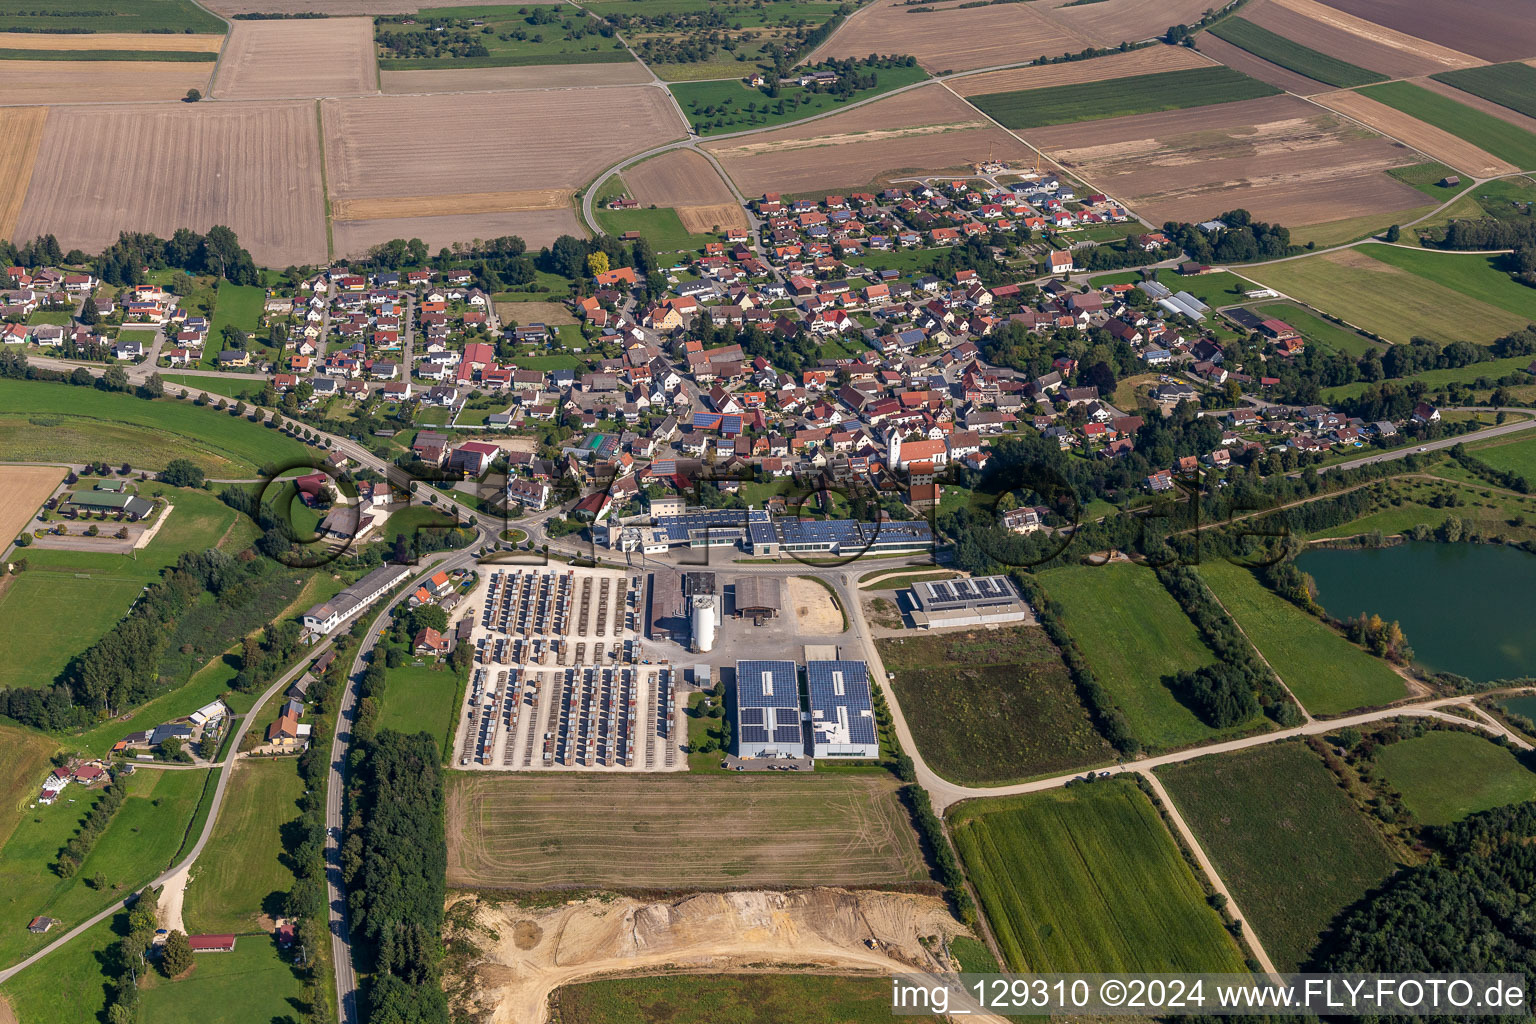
705 84 1035 195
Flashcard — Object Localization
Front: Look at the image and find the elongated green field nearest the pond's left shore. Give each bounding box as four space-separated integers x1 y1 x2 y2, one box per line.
1200 559 1407 715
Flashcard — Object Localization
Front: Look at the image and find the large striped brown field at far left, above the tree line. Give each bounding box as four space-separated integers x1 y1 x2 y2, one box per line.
15 103 326 267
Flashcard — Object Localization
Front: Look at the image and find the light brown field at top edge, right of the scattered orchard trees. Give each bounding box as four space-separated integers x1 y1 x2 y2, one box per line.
811 0 1087 72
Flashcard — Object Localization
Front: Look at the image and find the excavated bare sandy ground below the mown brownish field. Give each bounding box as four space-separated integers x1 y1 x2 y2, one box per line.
450 889 966 1024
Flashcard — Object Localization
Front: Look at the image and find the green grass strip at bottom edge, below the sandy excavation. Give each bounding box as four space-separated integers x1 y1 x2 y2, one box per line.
551 973 938 1024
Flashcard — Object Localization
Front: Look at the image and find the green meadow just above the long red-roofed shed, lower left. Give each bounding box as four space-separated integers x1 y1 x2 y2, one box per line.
183 761 304 933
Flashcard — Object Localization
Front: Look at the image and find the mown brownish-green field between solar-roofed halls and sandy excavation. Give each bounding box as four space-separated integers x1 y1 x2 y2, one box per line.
447 772 929 890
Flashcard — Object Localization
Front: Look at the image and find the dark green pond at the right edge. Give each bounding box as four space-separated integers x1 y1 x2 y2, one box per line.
1296 542 1536 682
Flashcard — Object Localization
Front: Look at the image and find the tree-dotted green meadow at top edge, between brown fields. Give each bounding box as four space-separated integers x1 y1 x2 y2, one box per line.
375 5 631 71
